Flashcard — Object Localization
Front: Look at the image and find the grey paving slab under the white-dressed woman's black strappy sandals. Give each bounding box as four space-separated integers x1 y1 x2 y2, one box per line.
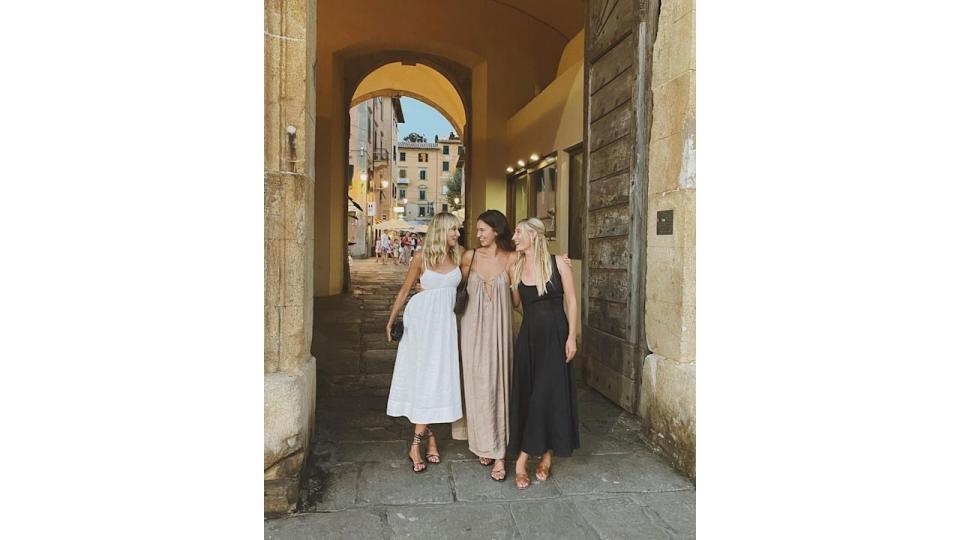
357 461 454 505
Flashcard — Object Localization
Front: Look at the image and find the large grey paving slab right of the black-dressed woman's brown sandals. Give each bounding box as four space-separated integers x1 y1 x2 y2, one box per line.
551 454 693 495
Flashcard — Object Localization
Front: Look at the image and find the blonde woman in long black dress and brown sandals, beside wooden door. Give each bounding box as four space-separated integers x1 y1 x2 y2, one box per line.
508 218 580 489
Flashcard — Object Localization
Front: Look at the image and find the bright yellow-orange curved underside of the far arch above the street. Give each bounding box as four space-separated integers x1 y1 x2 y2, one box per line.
350 62 467 138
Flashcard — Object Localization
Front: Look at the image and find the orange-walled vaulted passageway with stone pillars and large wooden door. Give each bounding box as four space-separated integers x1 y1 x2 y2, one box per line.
264 0 696 513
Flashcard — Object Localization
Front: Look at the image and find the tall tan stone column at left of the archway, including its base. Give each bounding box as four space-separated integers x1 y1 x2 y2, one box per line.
263 0 316 514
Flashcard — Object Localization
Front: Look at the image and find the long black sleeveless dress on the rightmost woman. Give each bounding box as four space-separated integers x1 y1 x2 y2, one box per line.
507 256 580 457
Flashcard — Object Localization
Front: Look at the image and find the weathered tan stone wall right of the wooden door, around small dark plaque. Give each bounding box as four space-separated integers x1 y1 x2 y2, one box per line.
638 0 697 477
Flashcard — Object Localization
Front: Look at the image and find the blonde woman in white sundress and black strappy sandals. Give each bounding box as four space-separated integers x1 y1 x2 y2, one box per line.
386 212 463 473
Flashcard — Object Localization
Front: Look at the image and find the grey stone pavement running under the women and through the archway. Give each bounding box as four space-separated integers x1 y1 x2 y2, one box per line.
264 255 695 540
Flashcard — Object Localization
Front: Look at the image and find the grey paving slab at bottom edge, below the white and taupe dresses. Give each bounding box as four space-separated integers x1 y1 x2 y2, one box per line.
387 504 520 540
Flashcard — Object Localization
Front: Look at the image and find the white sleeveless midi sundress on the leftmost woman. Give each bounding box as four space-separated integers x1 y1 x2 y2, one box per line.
387 268 463 424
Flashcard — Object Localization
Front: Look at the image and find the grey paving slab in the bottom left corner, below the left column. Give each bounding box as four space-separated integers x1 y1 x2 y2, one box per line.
263 509 388 540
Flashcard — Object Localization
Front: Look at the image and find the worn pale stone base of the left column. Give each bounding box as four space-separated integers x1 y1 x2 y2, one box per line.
263 357 317 516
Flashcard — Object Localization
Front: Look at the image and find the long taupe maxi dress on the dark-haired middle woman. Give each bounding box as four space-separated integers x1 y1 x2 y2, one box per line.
453 264 513 459
